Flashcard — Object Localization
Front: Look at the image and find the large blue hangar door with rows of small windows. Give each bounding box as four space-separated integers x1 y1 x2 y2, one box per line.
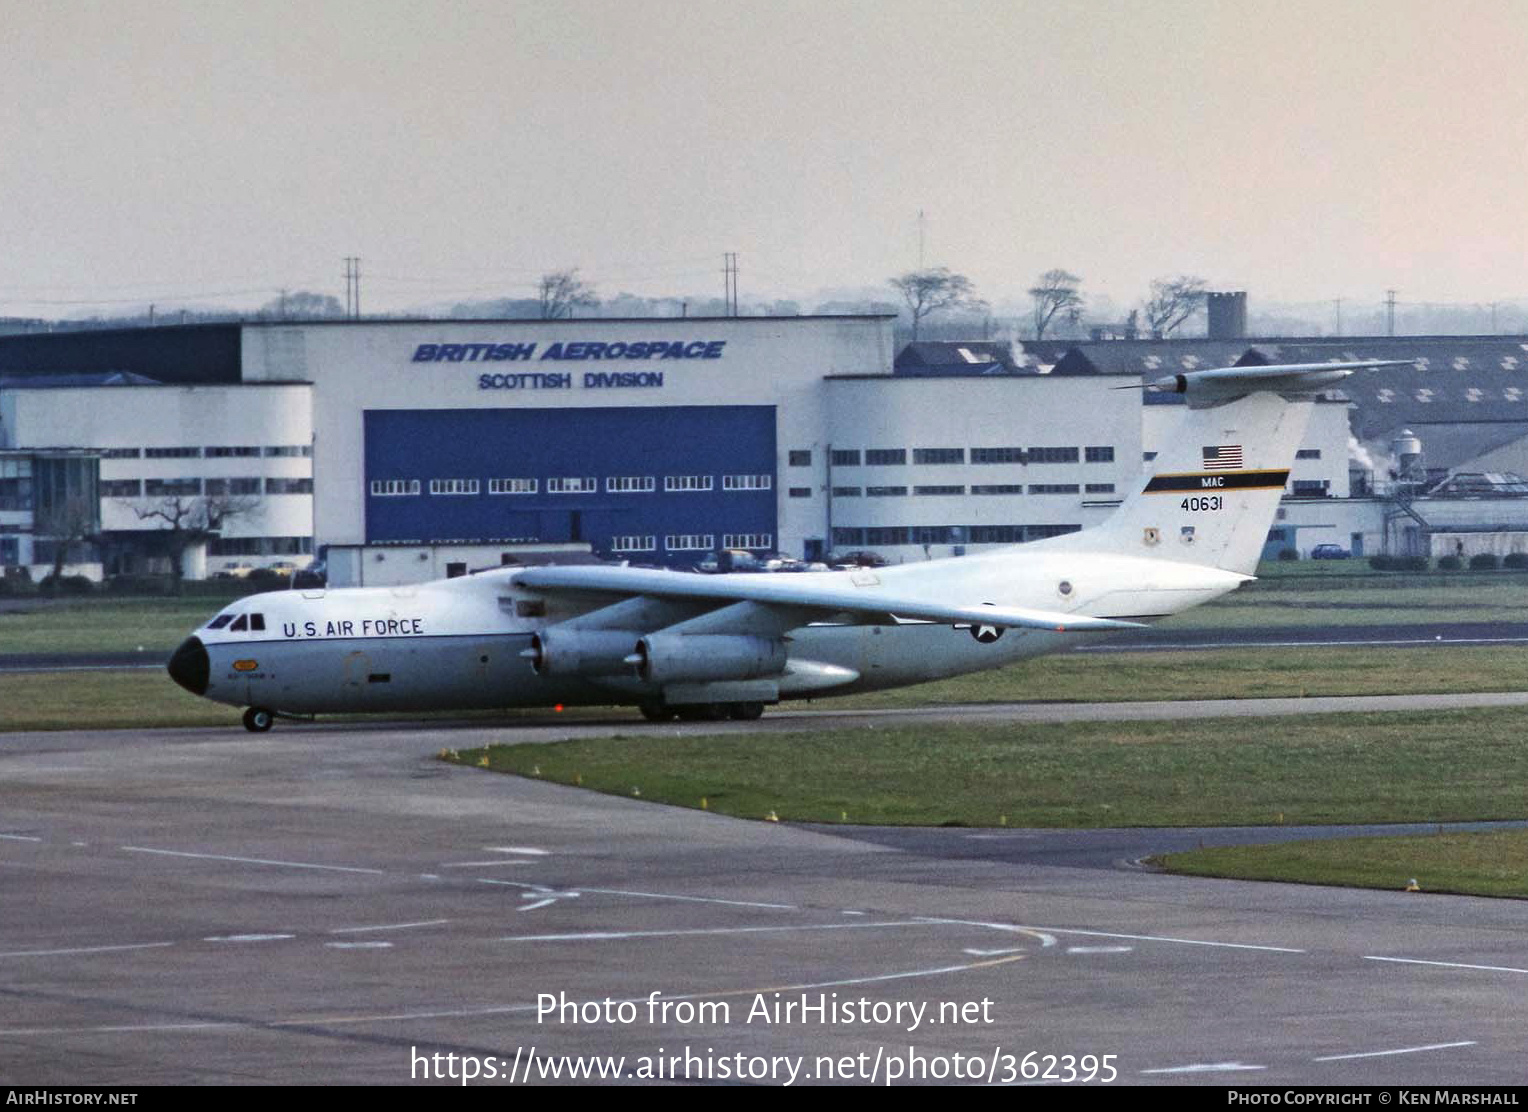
364 405 776 565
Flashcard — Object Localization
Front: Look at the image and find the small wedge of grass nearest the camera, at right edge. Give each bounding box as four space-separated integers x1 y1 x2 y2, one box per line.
1157 829 1528 898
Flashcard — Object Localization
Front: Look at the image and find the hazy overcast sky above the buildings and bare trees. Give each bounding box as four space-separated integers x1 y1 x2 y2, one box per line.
0 0 1528 315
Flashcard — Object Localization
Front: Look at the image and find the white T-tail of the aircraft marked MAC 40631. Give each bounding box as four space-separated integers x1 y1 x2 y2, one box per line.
1027 360 1410 576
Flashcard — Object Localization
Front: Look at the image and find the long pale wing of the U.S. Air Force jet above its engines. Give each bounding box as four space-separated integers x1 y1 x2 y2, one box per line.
510 567 1140 632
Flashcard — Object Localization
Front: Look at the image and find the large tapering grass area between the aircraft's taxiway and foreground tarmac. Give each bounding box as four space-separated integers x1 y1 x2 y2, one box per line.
446 709 1528 826
